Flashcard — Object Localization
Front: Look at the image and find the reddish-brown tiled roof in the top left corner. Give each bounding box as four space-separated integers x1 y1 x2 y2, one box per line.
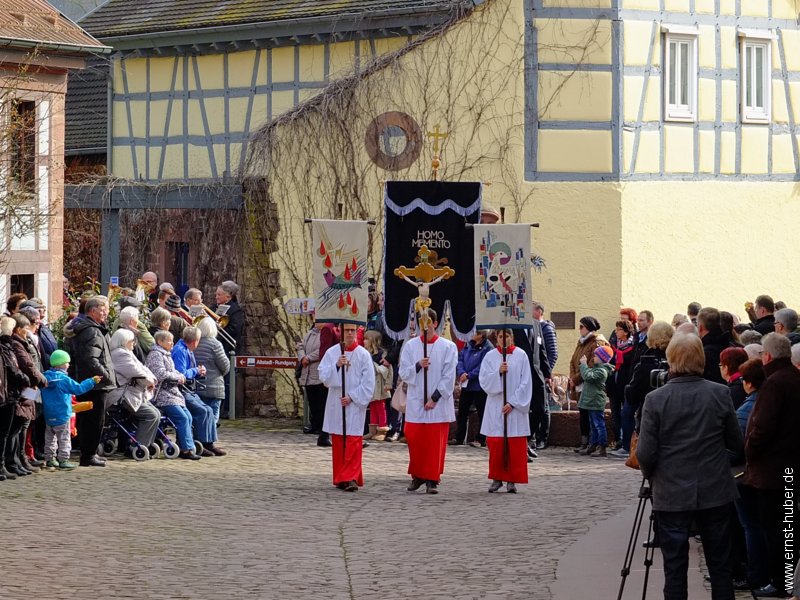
0 0 110 53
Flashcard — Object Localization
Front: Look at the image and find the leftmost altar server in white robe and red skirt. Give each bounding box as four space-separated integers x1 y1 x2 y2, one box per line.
319 323 375 492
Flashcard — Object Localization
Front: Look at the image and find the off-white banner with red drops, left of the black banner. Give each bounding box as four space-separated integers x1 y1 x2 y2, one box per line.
311 219 368 325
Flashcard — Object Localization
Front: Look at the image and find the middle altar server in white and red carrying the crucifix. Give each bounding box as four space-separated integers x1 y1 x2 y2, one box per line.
398 308 458 494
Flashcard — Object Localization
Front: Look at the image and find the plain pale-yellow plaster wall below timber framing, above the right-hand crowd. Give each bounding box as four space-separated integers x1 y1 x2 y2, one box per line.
621 181 800 321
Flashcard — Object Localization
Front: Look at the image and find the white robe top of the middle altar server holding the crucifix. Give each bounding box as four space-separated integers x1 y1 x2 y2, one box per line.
398 336 458 423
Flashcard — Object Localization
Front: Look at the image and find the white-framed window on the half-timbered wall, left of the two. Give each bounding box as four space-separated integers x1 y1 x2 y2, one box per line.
661 24 698 122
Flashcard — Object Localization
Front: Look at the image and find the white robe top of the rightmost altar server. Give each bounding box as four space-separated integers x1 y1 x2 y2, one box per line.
479 348 533 437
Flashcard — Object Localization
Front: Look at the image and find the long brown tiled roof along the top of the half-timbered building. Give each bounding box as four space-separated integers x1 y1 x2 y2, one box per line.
81 0 464 39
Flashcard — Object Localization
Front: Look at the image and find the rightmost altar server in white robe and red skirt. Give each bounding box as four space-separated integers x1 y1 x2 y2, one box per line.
478 329 532 494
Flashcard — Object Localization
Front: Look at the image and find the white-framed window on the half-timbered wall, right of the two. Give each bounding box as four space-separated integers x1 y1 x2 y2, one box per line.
739 29 774 123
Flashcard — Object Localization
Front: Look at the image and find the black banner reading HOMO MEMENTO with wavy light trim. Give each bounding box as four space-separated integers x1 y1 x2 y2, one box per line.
383 181 481 339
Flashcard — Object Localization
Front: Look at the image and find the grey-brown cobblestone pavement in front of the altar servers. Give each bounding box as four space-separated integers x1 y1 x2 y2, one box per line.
0 422 639 600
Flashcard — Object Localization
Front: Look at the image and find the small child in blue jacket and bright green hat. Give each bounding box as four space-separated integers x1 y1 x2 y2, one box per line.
42 350 100 471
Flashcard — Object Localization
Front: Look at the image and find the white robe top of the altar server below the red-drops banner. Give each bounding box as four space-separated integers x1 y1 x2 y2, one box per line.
319 344 375 437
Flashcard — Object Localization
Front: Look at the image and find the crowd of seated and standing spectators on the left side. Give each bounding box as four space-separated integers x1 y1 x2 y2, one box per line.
0 273 244 481
